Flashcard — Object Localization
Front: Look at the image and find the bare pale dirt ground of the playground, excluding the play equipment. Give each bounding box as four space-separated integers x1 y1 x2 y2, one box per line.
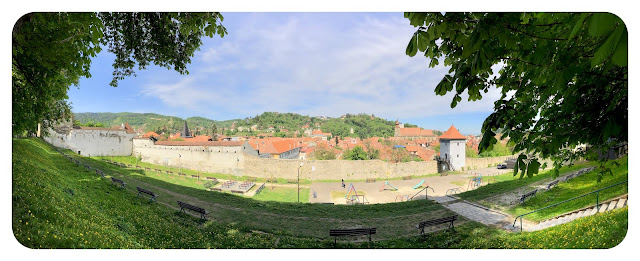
309 167 512 204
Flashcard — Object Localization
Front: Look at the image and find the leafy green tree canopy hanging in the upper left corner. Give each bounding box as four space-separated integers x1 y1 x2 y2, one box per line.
11 13 227 135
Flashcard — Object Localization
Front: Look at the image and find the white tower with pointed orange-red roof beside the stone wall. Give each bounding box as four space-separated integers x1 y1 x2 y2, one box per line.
439 125 467 170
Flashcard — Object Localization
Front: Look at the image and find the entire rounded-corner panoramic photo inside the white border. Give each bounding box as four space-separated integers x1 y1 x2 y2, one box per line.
11 12 629 249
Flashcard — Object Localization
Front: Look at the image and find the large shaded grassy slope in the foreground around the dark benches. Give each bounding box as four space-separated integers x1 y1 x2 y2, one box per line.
12 139 627 248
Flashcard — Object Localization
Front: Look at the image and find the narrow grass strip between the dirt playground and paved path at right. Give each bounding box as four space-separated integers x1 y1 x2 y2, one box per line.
457 163 595 201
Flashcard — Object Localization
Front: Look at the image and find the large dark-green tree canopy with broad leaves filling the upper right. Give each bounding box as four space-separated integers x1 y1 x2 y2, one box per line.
405 13 628 180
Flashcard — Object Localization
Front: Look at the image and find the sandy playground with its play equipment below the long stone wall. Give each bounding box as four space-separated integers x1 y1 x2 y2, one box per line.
309 168 512 204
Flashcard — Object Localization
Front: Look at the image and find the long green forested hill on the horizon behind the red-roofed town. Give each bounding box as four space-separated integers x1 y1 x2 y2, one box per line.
74 112 428 138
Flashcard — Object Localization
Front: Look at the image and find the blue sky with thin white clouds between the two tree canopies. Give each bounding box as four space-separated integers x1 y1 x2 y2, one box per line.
69 12 500 135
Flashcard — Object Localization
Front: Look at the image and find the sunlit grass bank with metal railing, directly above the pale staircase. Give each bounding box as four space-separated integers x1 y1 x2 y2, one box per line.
506 157 629 221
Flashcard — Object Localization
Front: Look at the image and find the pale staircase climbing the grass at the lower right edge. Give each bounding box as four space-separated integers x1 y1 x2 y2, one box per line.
523 195 628 231
